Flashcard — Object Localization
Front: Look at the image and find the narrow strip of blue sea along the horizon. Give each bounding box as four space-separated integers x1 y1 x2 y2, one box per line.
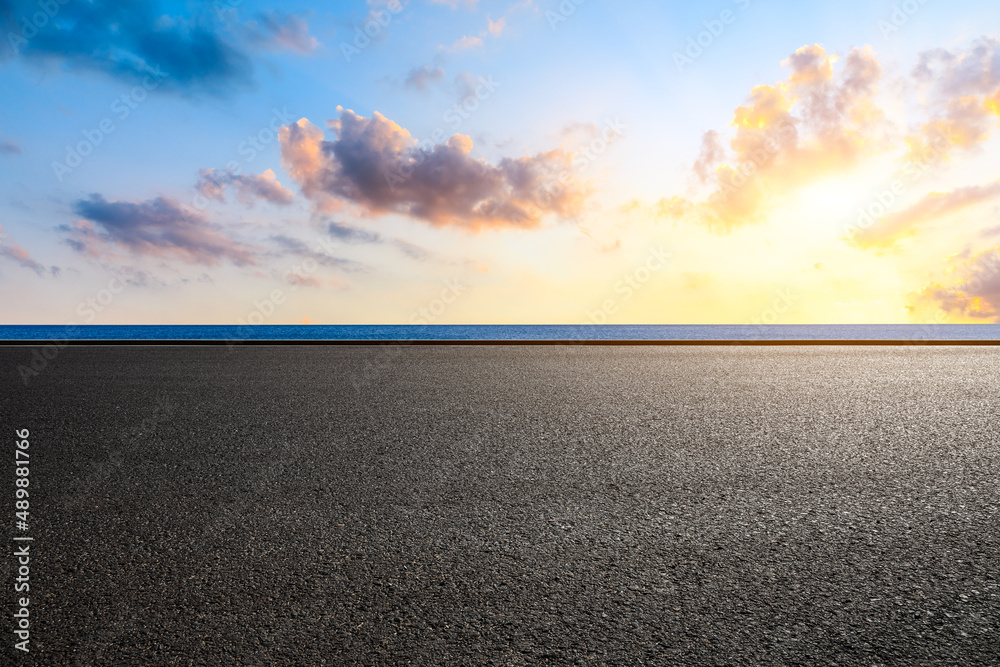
0 324 1000 340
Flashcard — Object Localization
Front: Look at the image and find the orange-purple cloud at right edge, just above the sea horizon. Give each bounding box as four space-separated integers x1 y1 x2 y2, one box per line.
907 247 1000 323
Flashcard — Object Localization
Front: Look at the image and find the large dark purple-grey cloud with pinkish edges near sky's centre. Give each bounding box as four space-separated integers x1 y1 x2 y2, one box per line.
279 107 587 230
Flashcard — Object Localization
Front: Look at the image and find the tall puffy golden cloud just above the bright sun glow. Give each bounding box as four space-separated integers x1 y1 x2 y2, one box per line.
659 44 889 232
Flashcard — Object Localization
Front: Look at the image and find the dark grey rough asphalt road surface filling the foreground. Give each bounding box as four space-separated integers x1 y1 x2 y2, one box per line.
0 346 1000 666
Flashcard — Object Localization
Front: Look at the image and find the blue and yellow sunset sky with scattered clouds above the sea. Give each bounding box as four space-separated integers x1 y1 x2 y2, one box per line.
0 0 1000 325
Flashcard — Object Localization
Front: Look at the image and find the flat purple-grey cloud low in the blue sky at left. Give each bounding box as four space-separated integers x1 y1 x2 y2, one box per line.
68 194 257 266
